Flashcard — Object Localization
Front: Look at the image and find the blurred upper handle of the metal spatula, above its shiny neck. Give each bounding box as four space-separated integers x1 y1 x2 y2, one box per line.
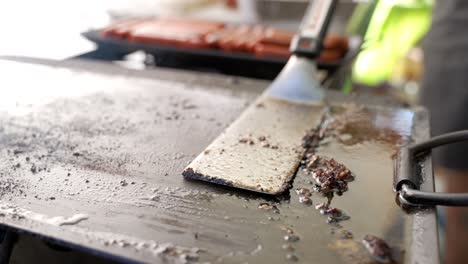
290 0 338 58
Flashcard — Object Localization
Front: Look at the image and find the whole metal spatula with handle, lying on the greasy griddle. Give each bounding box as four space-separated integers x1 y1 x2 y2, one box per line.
182 0 337 195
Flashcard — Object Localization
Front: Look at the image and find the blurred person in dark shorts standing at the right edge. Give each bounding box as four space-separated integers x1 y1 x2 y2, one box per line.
421 0 468 263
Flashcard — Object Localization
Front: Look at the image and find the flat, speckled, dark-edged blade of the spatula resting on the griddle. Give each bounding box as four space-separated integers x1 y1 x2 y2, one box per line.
183 95 324 195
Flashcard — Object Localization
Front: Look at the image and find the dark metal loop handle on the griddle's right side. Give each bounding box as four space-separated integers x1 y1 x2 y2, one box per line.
393 130 468 206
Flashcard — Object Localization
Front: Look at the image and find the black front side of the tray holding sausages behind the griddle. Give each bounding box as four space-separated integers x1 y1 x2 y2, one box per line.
82 30 340 79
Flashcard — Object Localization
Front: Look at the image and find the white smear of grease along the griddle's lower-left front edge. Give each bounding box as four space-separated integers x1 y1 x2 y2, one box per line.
0 204 88 226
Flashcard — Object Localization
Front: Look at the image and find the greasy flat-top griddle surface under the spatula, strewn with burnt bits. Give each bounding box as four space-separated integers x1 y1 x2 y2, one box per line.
0 60 437 263
